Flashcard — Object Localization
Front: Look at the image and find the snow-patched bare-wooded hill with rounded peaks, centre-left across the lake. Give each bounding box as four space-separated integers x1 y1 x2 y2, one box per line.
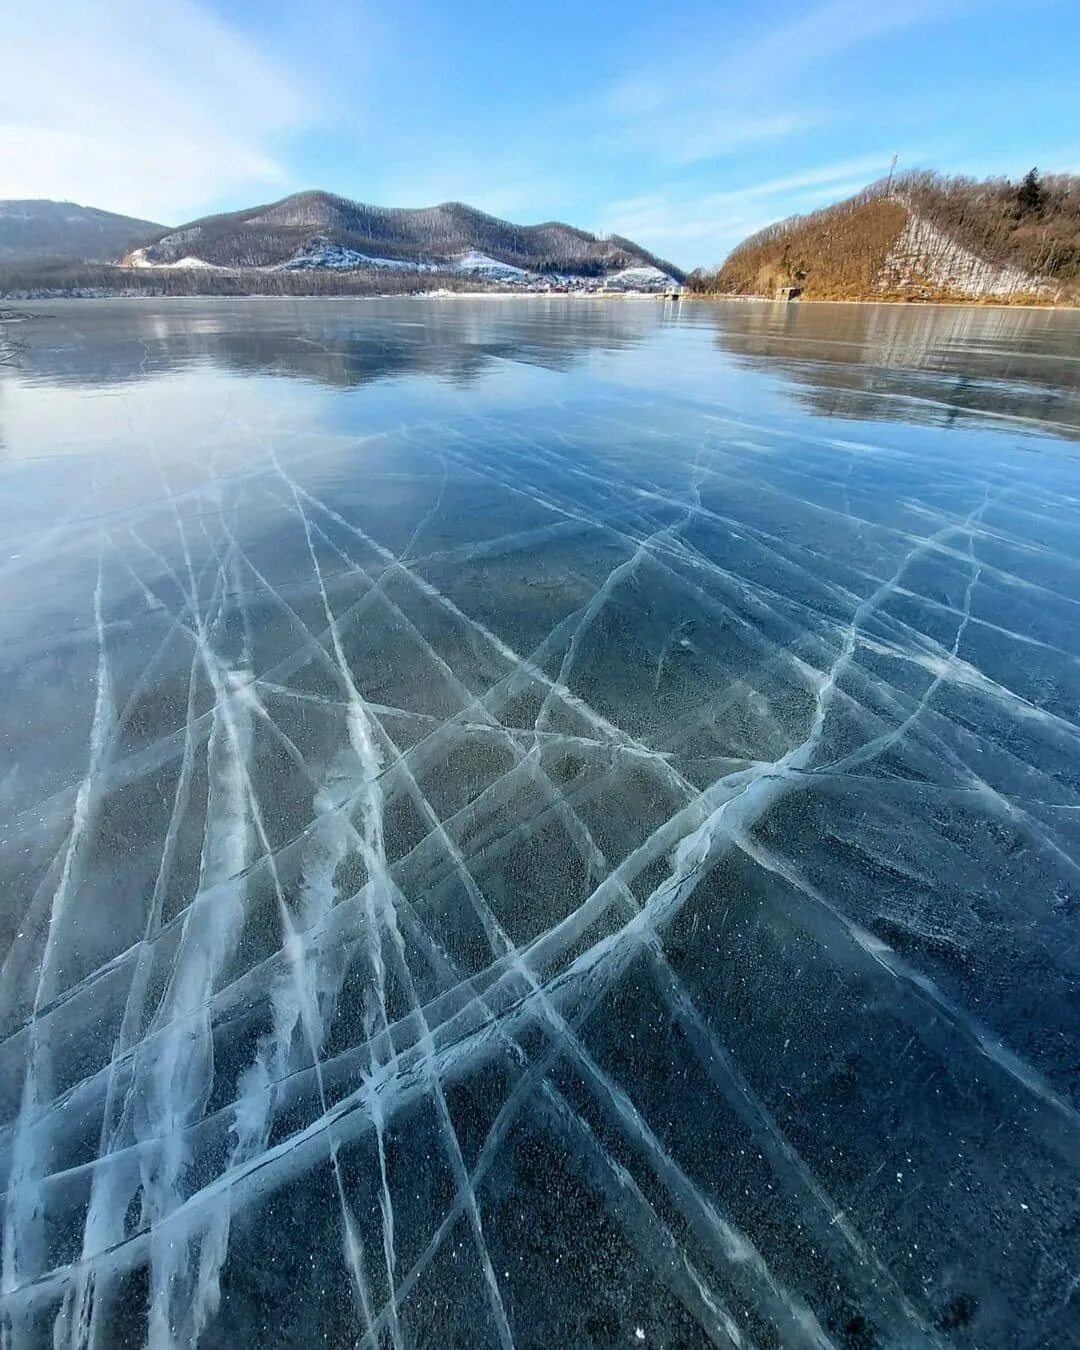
122 192 682 278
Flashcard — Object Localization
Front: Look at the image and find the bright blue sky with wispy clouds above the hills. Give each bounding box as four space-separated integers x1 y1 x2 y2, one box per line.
0 0 1080 266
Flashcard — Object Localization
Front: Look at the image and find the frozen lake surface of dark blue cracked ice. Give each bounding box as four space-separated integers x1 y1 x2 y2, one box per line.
0 300 1080 1350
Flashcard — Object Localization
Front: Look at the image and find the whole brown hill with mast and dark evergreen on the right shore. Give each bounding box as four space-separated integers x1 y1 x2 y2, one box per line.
690 169 1080 304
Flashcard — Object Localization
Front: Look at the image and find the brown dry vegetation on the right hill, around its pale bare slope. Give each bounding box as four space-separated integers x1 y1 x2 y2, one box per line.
689 171 1080 304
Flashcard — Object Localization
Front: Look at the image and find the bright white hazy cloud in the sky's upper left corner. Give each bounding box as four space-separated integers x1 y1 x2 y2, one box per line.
0 0 313 224
